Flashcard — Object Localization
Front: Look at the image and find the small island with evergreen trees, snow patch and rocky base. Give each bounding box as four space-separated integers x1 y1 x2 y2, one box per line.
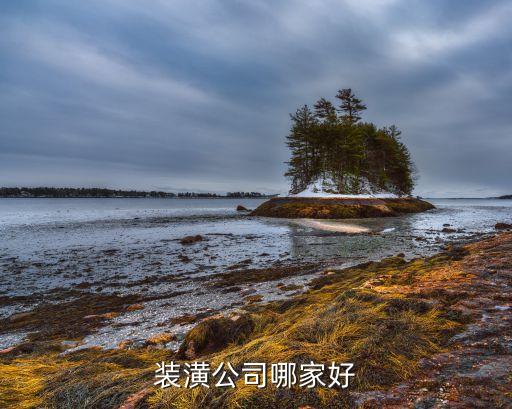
251 88 434 219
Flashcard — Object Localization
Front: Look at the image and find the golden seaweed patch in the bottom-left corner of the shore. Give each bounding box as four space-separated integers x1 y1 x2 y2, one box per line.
0 349 168 409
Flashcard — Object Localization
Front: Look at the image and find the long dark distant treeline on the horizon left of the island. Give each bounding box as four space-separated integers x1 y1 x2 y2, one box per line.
0 187 274 198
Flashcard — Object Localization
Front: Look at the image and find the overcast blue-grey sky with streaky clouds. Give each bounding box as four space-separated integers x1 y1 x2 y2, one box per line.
0 0 512 196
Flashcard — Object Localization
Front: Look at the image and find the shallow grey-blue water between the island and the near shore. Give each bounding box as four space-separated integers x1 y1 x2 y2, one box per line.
0 199 512 348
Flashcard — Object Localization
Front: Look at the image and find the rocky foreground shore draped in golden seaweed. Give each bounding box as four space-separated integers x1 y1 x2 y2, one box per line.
0 232 512 409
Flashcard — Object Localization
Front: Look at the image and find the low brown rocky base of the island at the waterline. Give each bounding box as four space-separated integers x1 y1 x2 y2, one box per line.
251 197 435 219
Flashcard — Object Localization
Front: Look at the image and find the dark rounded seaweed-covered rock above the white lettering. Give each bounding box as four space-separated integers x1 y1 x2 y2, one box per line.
177 314 254 359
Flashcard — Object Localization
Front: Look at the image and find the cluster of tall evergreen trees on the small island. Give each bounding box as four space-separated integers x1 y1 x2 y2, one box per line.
285 88 414 195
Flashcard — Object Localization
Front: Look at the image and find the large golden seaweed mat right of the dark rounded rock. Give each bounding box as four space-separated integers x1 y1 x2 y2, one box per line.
144 253 462 409
